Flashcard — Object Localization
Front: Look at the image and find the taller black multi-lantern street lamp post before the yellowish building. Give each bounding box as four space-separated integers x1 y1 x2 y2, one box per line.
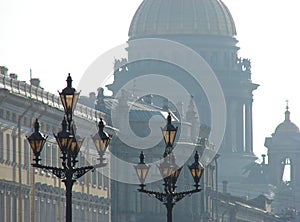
27 74 110 222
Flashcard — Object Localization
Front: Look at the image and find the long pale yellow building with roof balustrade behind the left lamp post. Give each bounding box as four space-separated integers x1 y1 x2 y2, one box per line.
0 70 111 222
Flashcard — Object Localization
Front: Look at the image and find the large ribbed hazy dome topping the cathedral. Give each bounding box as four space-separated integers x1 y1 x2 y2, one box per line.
128 0 236 38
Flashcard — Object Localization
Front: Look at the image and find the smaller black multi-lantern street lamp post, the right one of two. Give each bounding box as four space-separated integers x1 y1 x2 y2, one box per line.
135 113 204 222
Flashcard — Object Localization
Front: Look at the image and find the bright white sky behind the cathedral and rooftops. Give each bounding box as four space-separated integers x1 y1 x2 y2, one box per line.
0 0 300 160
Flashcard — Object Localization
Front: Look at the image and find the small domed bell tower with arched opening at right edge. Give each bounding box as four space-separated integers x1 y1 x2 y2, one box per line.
265 106 300 212
